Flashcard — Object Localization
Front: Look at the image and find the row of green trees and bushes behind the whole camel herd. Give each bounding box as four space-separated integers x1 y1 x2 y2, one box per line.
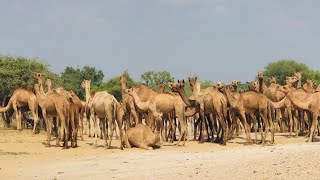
0 55 320 100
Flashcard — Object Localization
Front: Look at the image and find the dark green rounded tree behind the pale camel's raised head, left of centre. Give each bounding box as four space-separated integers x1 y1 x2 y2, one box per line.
61 66 104 99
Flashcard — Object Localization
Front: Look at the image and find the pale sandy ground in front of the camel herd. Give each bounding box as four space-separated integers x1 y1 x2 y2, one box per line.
0 129 320 179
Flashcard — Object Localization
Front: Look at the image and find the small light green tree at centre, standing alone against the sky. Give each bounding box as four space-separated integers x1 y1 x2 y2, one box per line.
141 71 174 89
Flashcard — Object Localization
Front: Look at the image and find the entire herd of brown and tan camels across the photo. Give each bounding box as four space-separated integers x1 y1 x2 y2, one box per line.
0 72 320 149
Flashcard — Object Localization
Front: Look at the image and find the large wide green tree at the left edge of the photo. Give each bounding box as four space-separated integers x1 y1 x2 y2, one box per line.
0 55 62 100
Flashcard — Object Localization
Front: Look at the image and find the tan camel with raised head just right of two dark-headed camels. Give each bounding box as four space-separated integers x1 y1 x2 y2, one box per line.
188 77 228 145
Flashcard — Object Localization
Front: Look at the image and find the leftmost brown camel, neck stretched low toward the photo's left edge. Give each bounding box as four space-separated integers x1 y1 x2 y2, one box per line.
0 88 39 134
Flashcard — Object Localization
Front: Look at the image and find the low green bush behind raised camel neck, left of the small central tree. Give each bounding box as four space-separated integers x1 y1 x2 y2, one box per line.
96 71 137 101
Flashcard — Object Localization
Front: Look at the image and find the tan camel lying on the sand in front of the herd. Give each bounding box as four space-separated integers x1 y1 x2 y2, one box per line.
123 121 162 150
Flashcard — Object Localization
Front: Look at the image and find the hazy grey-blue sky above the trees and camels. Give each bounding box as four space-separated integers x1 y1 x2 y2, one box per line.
0 0 320 82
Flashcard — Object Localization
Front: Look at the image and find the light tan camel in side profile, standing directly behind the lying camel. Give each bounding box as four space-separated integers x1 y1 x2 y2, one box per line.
125 87 187 146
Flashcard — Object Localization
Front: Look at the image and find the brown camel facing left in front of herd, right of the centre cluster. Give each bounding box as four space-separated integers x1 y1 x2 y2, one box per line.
225 86 274 144
